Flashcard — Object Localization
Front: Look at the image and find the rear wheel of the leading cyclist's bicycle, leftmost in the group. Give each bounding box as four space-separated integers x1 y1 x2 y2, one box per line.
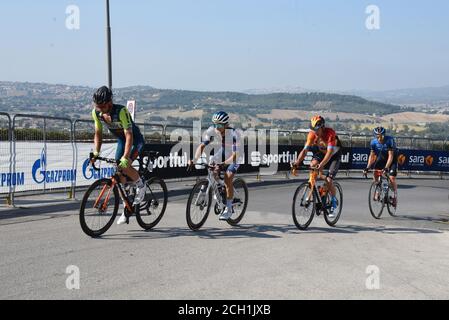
136 177 168 230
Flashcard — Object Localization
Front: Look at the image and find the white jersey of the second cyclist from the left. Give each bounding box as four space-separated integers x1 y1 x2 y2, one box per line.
202 126 243 164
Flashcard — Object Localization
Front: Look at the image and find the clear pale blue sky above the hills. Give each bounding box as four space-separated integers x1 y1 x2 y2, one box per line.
0 0 449 91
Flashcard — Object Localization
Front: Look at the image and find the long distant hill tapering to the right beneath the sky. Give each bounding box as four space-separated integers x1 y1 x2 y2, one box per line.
0 82 401 117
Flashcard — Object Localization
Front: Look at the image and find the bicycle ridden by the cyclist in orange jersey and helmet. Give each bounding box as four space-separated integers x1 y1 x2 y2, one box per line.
292 168 343 230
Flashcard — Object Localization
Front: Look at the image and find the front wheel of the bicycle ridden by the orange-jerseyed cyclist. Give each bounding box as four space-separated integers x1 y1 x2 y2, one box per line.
292 182 316 230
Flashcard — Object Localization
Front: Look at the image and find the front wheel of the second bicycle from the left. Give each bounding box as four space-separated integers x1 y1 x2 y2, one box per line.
186 179 212 231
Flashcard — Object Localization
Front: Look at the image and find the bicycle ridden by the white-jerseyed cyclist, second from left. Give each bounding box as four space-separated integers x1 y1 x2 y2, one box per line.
186 164 248 231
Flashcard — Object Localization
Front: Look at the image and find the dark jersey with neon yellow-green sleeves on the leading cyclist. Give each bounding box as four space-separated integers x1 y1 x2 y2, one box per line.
92 104 142 139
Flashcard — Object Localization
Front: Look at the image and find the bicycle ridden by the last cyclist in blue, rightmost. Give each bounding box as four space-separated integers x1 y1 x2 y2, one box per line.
364 169 398 219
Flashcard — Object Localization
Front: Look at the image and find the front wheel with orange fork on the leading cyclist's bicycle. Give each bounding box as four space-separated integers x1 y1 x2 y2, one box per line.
80 179 120 237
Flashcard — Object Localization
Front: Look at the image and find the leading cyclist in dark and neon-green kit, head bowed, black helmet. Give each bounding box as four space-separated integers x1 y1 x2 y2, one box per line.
92 86 146 224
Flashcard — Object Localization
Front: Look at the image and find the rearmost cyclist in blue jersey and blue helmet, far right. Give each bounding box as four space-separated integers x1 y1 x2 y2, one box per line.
364 127 398 206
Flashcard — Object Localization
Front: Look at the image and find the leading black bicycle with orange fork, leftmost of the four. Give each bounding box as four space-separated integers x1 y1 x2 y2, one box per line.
80 151 168 237
